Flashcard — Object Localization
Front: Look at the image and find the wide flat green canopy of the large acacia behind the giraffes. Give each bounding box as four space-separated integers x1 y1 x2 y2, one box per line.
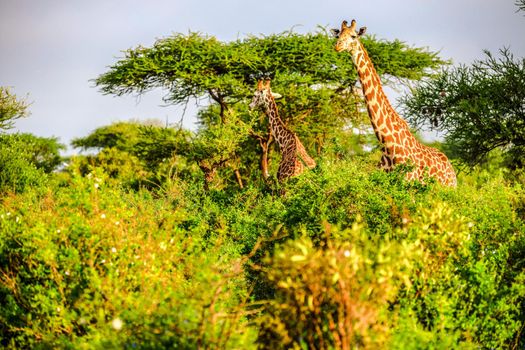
95 30 446 104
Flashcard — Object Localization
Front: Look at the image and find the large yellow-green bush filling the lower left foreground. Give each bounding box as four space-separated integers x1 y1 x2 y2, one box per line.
0 172 254 348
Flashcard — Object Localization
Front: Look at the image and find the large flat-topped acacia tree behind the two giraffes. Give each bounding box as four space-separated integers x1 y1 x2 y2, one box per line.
95 30 445 185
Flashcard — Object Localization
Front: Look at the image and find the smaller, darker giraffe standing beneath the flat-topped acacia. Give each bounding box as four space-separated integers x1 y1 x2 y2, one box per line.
250 79 316 182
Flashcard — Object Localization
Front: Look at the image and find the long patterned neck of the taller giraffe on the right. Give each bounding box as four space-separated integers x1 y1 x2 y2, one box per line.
352 43 414 150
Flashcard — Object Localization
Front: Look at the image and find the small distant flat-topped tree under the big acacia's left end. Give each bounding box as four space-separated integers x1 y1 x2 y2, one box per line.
68 121 193 188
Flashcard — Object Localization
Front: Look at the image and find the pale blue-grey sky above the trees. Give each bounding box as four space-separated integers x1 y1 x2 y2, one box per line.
0 0 525 151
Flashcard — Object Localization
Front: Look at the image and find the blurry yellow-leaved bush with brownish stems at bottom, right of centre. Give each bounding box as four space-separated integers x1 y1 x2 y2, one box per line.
259 223 413 349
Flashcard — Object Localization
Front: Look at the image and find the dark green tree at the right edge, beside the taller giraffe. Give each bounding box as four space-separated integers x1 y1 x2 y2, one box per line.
403 49 525 168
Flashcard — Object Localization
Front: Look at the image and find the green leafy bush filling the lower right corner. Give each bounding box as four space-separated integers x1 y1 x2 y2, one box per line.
392 179 525 348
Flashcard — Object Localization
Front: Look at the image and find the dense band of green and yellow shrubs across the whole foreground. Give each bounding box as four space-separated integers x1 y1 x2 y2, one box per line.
0 153 525 349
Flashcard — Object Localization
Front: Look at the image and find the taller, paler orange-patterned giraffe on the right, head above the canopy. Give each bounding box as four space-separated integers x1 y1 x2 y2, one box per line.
334 20 456 187
